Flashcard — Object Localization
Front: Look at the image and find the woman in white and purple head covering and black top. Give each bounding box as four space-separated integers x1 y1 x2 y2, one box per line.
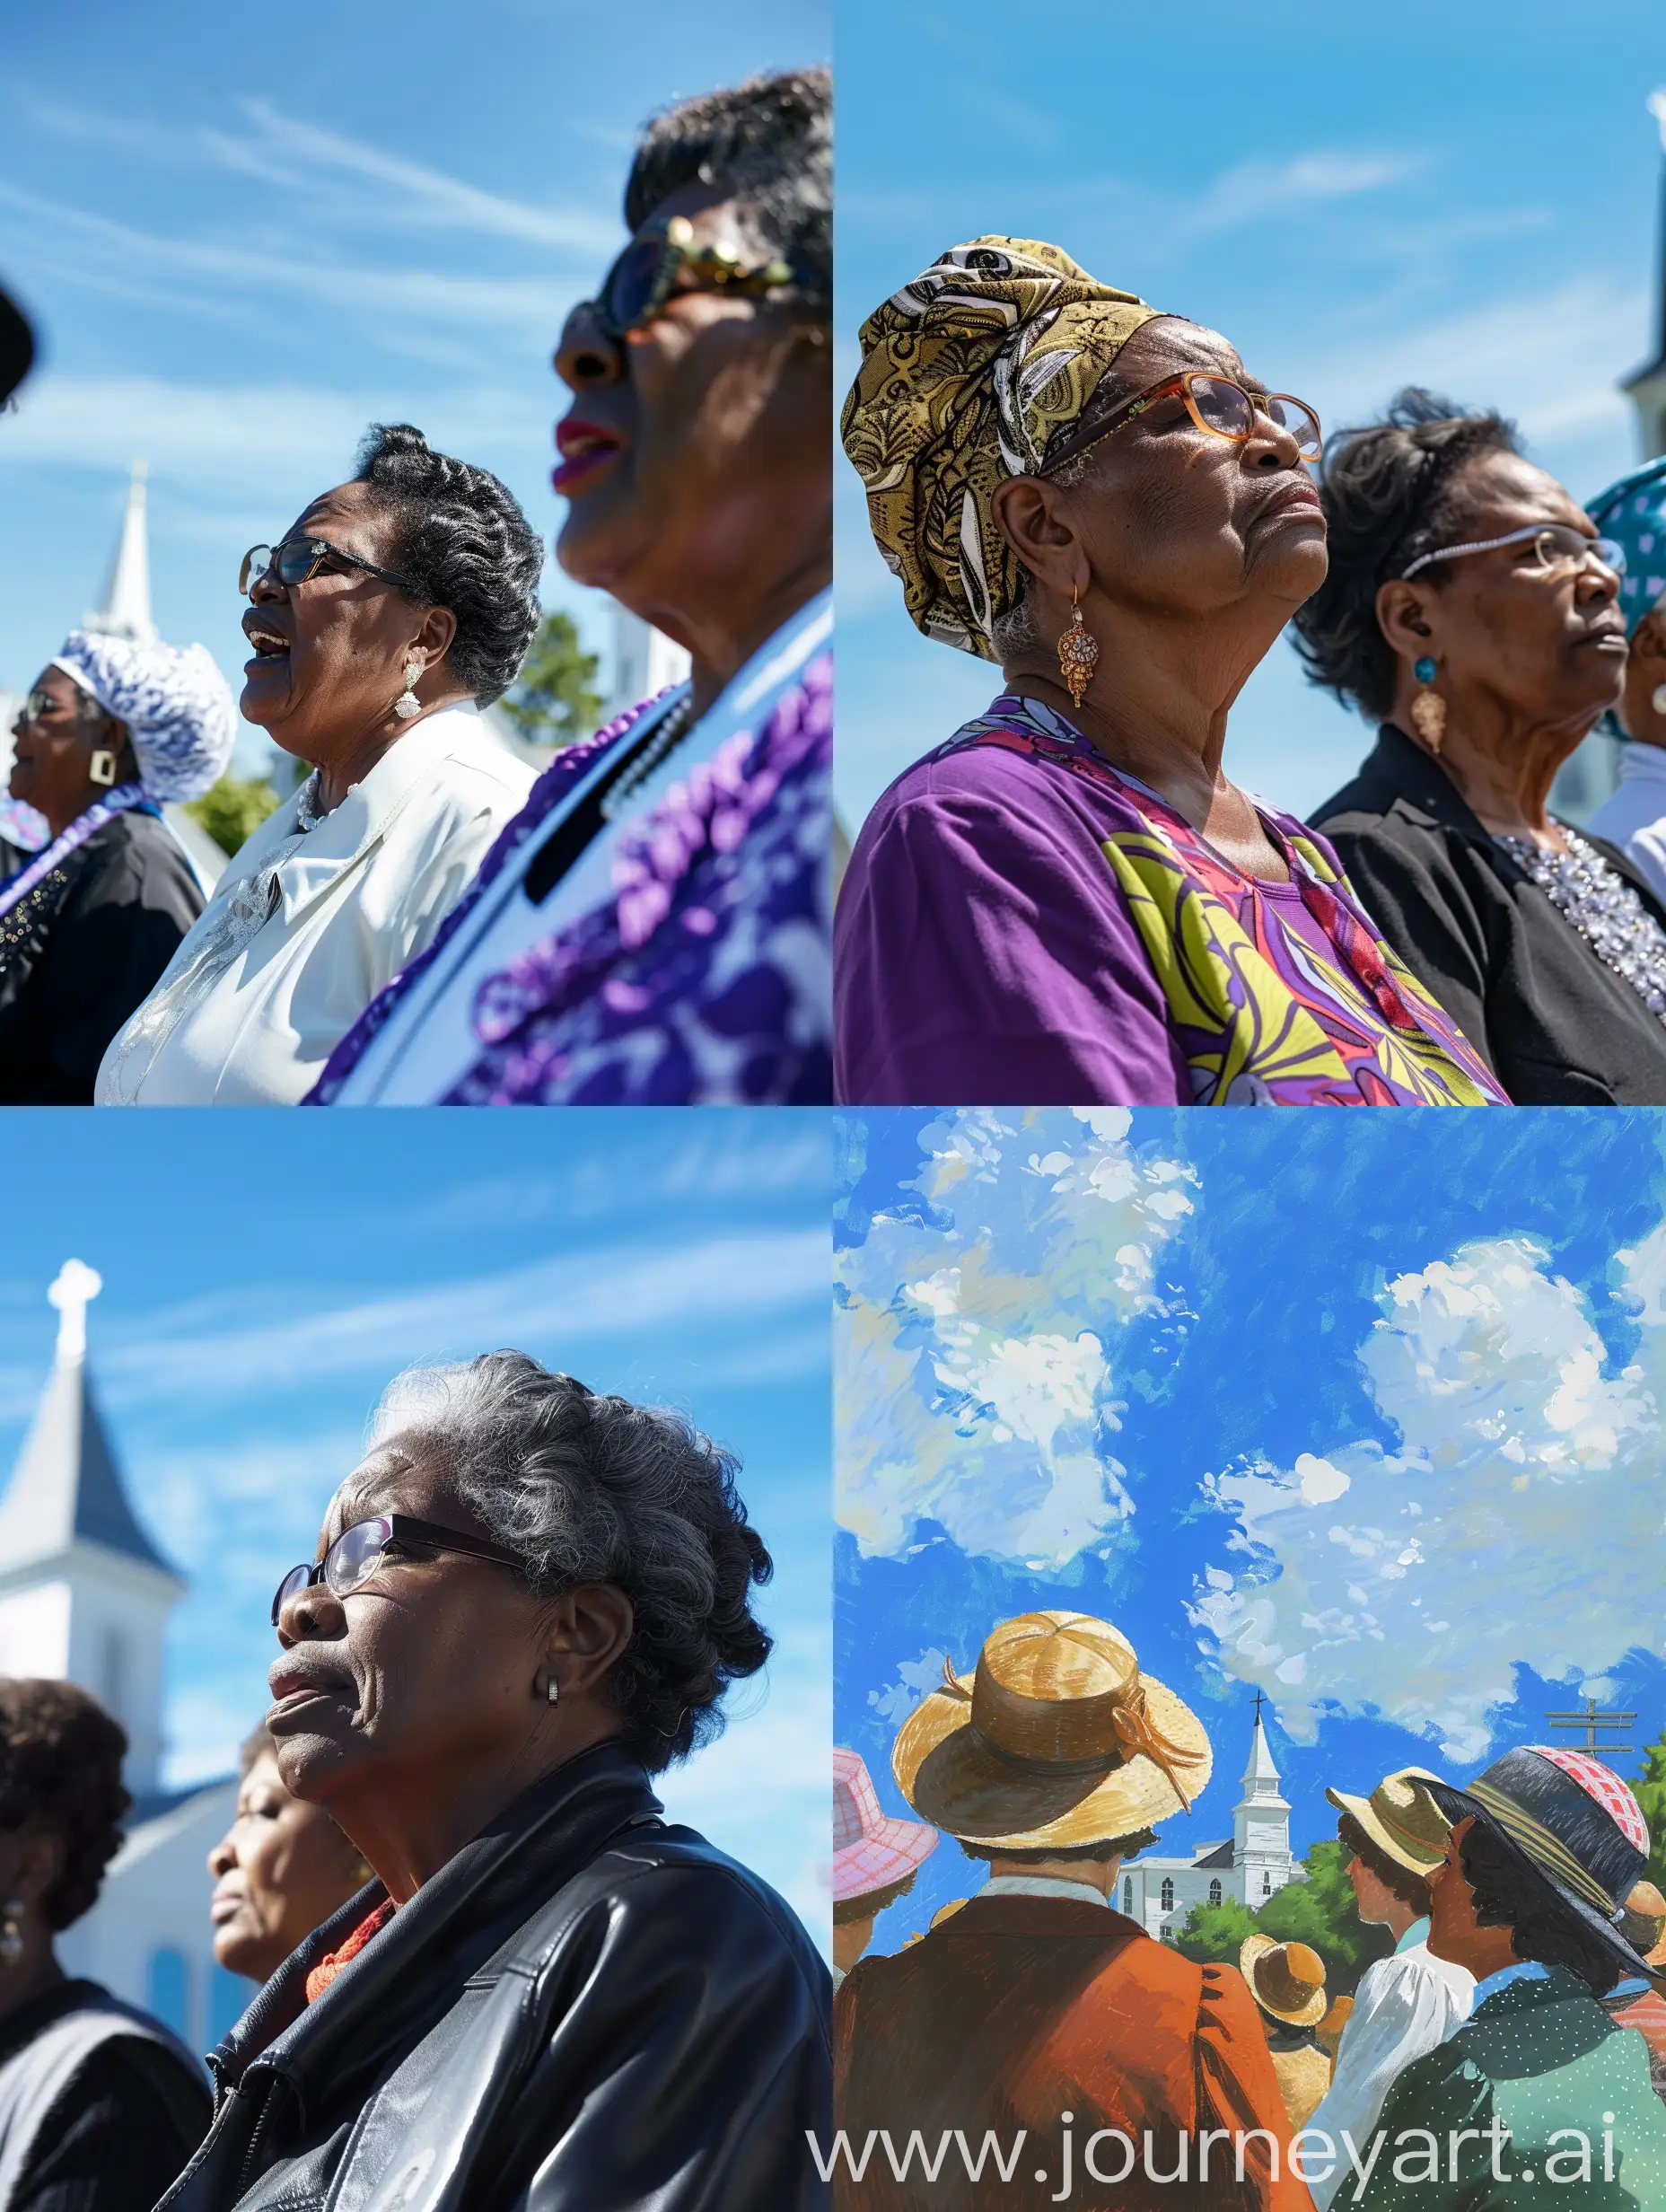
0 630 237 1106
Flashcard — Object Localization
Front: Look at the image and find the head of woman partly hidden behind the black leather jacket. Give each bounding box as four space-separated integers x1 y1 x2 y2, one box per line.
208 1727 372 1982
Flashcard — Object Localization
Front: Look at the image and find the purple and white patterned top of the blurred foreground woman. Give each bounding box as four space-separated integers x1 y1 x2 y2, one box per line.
303 592 832 1106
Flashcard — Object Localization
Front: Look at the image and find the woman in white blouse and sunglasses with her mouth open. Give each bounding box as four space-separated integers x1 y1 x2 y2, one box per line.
97 425 542 1106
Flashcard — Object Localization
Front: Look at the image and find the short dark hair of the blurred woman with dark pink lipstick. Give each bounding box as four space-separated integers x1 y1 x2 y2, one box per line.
624 68 832 314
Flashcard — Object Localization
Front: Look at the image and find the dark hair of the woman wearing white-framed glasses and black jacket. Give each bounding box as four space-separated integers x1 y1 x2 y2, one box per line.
1292 385 1522 721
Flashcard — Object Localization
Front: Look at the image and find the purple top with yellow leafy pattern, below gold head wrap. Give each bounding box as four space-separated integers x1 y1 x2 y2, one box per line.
834 695 1509 1106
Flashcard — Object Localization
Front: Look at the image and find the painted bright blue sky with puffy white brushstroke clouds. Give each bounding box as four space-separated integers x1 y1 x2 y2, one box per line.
834 1108 1666 1949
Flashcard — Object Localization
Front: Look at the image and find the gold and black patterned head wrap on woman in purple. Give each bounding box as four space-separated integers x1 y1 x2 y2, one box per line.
841 239 1160 662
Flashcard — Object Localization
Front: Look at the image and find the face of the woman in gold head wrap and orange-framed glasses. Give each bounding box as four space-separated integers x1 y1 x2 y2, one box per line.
1039 316 1325 615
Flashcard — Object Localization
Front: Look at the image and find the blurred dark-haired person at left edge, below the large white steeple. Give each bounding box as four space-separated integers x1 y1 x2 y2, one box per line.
0 1679 208 2212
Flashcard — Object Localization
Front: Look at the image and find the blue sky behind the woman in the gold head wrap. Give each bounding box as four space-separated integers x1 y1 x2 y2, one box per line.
838 0 1666 828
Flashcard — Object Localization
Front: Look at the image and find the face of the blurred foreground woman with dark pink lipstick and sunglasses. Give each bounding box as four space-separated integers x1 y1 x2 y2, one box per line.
551 184 832 604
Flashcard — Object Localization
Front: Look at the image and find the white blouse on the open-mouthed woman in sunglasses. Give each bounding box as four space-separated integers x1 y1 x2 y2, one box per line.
95 706 535 1106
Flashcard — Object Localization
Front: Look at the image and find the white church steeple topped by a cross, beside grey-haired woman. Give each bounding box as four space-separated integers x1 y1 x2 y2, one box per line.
0 1259 186 1796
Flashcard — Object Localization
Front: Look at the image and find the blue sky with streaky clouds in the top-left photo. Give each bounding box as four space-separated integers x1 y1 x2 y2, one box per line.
0 0 829 778
